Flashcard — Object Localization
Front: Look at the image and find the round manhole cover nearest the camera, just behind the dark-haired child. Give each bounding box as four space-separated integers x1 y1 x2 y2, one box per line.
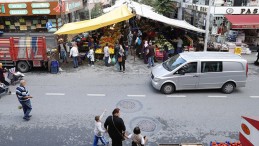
130 117 161 133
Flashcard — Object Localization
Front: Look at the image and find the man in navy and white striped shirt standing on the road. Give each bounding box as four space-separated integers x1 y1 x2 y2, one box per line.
16 80 32 121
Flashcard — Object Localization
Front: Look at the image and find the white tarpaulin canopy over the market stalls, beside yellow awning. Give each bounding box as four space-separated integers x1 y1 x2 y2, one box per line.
104 0 205 33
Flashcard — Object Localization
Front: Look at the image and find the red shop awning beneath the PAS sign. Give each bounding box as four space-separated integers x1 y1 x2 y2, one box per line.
225 15 259 29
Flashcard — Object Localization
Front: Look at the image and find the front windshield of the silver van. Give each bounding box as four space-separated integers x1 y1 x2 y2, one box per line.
163 54 186 71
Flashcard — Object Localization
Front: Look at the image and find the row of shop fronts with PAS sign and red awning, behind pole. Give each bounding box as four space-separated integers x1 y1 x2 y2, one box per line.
175 0 259 50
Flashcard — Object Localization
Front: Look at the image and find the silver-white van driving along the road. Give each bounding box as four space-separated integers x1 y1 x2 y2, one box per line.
151 52 248 94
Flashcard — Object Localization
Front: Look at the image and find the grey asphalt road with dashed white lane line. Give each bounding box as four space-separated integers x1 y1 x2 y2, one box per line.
0 56 259 146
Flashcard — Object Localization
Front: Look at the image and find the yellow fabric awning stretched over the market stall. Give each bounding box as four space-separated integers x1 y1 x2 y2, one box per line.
54 5 134 35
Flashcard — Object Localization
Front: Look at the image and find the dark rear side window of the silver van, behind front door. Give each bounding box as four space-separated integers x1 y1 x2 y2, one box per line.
201 61 222 73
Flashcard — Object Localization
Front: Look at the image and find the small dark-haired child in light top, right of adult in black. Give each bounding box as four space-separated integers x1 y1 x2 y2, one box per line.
127 127 147 146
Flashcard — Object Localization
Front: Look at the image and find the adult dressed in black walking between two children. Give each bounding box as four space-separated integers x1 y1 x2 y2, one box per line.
104 108 126 146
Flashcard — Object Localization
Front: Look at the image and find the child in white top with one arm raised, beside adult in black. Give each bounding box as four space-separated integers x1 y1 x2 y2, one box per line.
93 110 109 146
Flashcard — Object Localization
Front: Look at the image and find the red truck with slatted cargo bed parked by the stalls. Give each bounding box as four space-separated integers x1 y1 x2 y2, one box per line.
0 37 48 72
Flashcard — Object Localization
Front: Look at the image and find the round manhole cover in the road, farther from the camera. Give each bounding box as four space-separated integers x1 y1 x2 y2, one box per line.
117 99 142 113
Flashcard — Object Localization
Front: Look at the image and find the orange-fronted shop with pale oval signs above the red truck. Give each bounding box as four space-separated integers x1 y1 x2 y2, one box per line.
0 2 61 33
